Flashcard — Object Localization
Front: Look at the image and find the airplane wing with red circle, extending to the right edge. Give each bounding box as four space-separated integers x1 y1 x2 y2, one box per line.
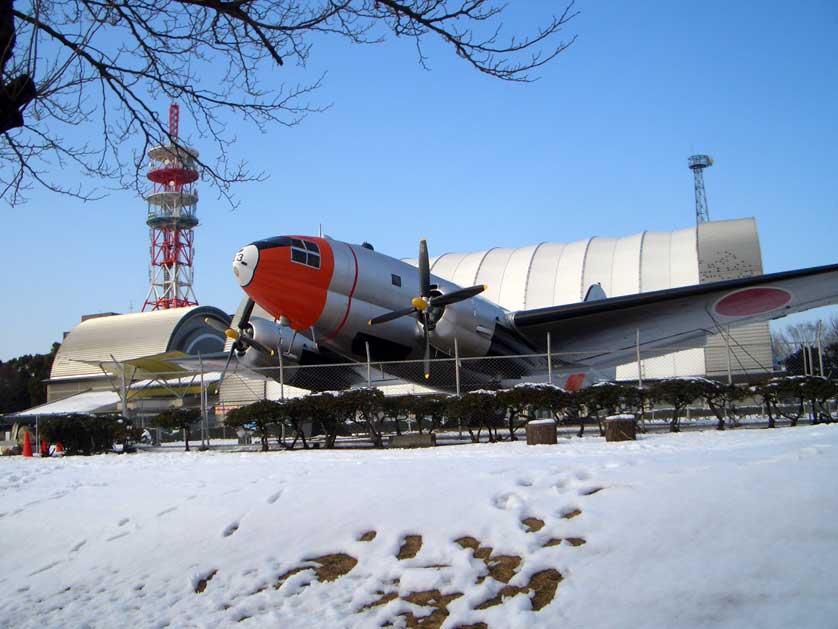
509 265 838 367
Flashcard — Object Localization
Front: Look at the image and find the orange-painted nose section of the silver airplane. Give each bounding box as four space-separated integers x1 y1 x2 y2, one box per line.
240 236 335 330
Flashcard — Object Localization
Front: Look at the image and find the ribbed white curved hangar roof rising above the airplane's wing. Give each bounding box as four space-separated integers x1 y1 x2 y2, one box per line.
414 218 762 310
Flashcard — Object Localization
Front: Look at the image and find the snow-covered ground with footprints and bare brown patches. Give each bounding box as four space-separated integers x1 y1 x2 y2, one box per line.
0 426 838 628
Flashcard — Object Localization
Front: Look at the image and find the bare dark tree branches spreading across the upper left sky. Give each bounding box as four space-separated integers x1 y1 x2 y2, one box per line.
0 0 576 206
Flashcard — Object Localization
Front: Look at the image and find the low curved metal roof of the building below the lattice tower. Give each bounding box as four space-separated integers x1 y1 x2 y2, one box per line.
50 306 230 380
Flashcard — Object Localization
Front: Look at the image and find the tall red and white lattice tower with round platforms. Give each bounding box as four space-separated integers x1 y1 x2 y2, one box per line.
143 104 198 310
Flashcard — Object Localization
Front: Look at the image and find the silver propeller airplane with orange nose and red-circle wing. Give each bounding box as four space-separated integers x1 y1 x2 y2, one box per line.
203 235 838 390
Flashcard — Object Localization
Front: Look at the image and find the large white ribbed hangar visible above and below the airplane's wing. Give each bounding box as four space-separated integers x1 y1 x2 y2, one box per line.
426 218 771 379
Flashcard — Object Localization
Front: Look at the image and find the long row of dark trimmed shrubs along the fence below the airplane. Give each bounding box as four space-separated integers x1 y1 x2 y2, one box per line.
225 376 838 450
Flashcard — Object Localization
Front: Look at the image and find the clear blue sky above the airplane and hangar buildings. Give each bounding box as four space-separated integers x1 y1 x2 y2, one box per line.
0 0 838 360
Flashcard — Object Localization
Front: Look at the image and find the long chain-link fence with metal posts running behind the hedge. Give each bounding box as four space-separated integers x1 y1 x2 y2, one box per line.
64 335 831 432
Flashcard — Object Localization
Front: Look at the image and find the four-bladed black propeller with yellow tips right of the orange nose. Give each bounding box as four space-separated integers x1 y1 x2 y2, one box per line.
368 238 487 379
